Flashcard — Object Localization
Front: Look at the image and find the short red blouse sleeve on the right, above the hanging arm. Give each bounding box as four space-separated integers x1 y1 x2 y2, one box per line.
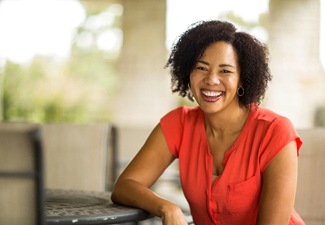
260 117 302 172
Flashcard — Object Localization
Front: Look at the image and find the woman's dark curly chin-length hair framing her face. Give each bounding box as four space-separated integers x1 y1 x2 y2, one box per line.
165 20 272 107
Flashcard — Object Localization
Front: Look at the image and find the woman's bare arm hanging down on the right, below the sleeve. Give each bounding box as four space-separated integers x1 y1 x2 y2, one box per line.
257 141 298 225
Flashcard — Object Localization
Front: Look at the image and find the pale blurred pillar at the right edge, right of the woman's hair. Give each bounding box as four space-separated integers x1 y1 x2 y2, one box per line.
265 0 325 128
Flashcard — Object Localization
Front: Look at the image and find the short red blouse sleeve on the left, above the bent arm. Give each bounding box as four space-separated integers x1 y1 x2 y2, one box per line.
160 107 186 158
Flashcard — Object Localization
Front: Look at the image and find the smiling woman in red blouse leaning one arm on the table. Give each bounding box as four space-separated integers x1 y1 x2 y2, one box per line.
112 21 304 225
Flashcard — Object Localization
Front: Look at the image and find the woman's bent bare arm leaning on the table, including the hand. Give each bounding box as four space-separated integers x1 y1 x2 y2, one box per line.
112 125 187 225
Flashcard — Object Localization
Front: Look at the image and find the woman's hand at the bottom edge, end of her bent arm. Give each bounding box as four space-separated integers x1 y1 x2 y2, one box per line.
161 204 188 225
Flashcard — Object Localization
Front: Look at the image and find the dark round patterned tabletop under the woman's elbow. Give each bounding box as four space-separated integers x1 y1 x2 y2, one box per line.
45 190 153 225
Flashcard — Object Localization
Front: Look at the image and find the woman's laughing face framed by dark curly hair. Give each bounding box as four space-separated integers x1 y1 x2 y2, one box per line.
190 41 240 113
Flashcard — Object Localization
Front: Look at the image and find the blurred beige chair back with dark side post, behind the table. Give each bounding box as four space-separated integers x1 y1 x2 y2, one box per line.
41 124 118 191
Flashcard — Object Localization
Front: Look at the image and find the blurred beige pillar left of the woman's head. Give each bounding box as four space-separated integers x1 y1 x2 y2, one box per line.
114 0 174 127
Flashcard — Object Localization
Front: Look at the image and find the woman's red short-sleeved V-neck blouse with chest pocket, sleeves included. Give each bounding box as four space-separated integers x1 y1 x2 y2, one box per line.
160 105 304 225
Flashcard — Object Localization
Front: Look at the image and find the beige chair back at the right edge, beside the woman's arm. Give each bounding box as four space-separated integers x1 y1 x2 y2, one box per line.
295 128 325 225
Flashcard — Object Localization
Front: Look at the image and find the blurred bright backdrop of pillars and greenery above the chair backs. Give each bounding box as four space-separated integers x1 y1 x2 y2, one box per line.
0 0 325 128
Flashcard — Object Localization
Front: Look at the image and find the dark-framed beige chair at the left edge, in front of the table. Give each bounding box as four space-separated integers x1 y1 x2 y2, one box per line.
0 124 44 225
